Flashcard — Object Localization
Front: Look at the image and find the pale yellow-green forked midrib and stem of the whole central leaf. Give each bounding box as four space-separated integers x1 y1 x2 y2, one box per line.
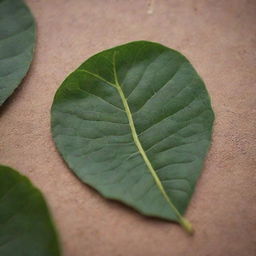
80 52 193 233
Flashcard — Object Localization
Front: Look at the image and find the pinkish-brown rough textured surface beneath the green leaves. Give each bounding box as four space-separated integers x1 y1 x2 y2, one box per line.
0 0 256 256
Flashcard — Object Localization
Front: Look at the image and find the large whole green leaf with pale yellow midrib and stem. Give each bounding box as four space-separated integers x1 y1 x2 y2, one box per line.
52 41 214 232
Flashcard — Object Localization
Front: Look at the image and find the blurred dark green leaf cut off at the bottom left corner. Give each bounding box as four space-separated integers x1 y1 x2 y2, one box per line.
0 165 60 256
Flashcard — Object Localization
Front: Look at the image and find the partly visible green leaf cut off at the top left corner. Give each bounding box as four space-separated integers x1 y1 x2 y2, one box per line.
0 0 35 105
